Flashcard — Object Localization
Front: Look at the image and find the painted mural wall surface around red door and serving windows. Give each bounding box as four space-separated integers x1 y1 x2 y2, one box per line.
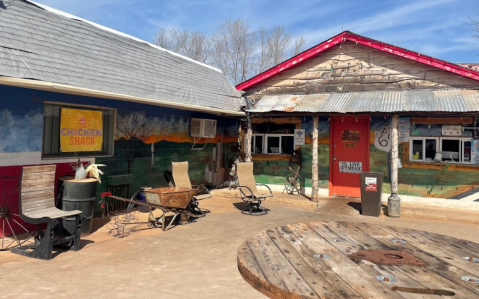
254 116 479 199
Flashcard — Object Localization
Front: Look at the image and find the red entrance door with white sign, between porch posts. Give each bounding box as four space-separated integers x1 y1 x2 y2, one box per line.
329 116 369 197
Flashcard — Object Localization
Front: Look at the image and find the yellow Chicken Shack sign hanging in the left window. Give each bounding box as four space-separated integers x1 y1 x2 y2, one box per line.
60 108 103 153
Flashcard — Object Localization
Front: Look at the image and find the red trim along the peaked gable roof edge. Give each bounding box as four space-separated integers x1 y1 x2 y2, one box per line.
236 31 479 90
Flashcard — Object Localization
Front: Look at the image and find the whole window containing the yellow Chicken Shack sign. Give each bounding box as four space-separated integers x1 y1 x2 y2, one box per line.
42 102 116 159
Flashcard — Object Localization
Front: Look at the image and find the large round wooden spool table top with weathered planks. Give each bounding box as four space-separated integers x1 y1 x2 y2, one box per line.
238 222 479 299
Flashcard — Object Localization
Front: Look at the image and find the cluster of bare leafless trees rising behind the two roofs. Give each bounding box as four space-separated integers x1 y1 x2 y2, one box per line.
155 19 305 85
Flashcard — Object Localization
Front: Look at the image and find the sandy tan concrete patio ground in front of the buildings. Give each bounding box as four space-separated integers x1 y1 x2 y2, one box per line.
0 196 479 299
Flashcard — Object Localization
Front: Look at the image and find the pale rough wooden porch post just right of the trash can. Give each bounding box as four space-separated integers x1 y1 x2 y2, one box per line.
388 114 401 217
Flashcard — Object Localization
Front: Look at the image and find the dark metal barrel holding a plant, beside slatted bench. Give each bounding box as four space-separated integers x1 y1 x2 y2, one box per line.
62 178 98 236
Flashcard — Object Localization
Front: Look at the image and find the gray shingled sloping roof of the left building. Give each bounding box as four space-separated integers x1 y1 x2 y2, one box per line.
0 0 243 111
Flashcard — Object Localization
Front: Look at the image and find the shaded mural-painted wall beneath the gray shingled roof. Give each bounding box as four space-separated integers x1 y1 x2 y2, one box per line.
0 86 239 227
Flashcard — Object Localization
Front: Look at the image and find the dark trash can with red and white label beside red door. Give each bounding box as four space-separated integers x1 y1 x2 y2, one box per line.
359 172 383 217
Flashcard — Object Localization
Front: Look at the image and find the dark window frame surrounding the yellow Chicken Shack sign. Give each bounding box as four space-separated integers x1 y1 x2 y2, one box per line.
41 101 117 160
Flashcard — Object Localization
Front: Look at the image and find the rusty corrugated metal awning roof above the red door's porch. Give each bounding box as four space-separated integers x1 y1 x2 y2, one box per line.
248 89 479 113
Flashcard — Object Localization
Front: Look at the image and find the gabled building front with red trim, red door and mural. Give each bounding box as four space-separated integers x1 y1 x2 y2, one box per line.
236 32 479 209
